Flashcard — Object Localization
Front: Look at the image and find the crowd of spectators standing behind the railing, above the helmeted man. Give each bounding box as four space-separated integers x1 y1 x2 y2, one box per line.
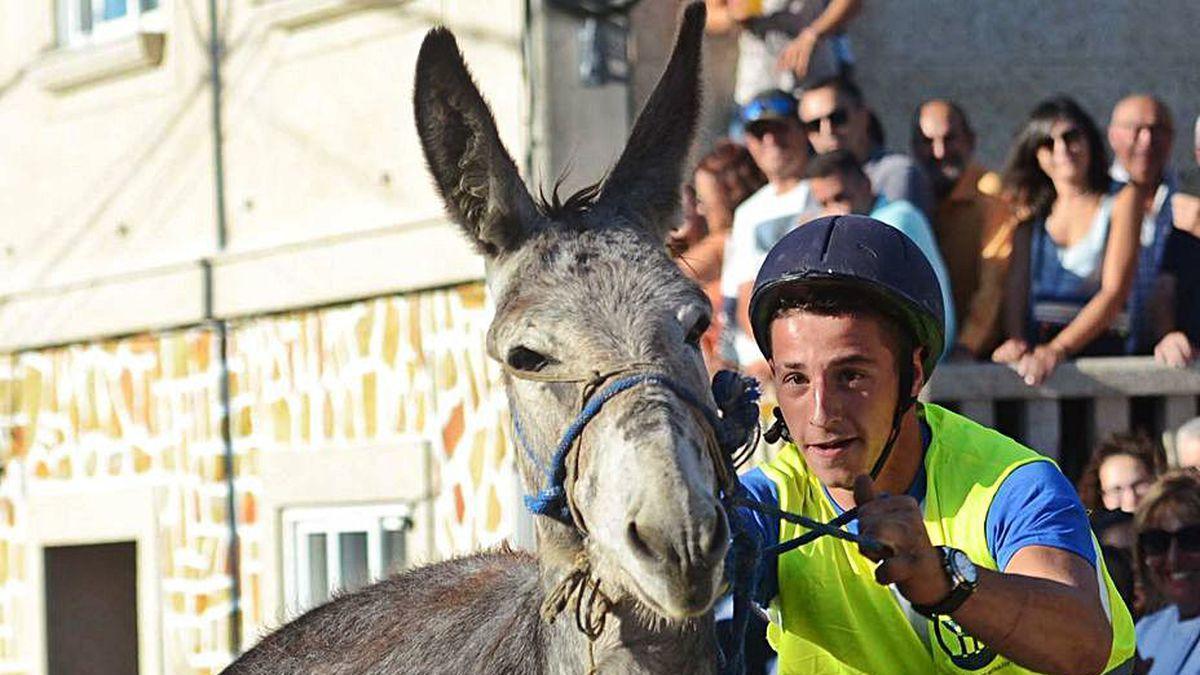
672 76 1200 386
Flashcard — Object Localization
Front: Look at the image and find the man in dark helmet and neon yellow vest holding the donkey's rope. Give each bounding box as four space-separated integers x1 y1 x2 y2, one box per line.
740 215 1134 674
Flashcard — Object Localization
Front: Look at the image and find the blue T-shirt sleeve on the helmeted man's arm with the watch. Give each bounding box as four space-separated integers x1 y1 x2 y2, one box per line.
986 461 1096 571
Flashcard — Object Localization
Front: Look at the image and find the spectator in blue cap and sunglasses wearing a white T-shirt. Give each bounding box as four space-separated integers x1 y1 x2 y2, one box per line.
721 89 816 376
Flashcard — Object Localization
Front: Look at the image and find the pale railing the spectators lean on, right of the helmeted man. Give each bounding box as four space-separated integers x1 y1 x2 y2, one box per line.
920 357 1200 477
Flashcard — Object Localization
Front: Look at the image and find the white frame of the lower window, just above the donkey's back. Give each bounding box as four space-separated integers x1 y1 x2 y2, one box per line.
282 502 413 613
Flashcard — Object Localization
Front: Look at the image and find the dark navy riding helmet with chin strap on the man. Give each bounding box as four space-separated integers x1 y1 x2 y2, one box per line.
750 215 946 478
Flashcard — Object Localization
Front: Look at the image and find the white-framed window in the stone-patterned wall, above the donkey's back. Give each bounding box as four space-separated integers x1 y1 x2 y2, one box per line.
283 504 413 613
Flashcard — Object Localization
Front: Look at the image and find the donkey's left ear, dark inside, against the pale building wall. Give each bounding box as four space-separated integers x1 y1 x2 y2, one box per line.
413 28 539 257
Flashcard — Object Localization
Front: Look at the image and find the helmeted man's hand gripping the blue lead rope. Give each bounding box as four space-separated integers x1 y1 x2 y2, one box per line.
854 476 950 604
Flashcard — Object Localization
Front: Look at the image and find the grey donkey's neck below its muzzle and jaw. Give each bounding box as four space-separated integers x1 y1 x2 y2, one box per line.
539 533 716 674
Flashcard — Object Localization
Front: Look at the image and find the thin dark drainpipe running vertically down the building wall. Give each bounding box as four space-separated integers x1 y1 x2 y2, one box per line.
202 0 241 656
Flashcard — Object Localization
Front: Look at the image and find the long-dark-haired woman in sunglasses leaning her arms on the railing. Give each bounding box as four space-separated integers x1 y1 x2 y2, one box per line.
992 96 1141 386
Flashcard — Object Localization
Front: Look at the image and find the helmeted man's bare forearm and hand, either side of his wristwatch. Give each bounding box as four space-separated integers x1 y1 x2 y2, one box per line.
854 476 1112 674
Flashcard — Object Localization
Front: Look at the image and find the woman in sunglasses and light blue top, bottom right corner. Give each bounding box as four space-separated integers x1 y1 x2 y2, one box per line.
1134 471 1200 675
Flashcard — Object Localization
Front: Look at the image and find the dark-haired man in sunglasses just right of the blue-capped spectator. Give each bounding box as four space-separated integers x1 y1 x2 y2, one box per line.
800 77 934 217
